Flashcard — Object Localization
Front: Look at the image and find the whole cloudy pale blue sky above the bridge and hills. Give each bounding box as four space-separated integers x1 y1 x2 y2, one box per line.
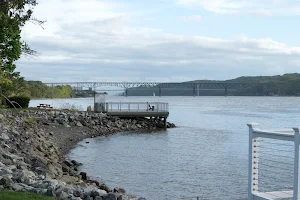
17 0 300 83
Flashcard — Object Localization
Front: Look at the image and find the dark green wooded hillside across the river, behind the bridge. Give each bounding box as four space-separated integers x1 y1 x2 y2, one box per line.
127 73 300 96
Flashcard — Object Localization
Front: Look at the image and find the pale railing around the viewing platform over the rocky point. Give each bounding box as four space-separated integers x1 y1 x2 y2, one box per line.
105 102 169 112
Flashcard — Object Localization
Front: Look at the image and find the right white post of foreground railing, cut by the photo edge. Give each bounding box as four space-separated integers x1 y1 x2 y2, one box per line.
293 128 300 200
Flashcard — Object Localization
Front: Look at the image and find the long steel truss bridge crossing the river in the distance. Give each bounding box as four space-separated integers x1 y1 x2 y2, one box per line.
44 81 263 96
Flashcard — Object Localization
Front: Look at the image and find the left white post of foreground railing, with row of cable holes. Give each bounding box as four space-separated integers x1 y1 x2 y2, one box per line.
248 123 260 200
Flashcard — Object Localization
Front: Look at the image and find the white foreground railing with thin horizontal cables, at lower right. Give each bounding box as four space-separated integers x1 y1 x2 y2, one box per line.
248 123 300 200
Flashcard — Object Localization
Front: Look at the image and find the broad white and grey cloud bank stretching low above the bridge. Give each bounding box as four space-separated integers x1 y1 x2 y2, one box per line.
17 0 300 82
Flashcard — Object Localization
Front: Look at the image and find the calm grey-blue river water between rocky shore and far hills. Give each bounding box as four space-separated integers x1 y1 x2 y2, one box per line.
31 97 300 200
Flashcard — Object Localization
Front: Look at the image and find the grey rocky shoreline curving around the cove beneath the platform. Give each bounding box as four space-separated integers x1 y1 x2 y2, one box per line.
0 110 175 200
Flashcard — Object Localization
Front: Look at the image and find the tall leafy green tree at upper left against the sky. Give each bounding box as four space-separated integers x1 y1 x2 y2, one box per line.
0 0 43 96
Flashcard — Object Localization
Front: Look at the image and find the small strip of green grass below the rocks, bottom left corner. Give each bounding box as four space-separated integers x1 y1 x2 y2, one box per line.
0 190 54 200
